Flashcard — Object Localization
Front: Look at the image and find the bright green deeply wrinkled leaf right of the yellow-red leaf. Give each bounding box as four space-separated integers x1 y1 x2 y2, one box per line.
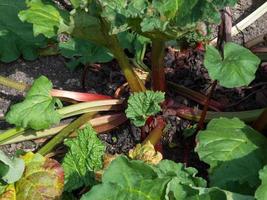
62 125 105 191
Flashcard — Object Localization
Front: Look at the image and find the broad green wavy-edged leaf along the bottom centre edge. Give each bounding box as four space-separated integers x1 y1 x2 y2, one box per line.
82 156 213 200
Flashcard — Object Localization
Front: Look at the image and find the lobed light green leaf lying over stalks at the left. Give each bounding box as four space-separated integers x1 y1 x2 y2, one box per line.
6 76 61 130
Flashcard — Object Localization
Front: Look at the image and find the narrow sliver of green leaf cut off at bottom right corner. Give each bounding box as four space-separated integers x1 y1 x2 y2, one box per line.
255 166 267 200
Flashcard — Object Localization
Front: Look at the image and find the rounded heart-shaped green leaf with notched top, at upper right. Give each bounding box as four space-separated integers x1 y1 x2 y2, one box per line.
204 43 260 88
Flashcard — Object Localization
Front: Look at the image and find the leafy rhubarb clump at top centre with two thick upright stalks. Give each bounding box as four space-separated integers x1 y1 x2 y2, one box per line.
19 0 240 92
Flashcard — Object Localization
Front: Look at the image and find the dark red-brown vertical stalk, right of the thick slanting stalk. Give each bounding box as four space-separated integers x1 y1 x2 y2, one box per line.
152 39 166 92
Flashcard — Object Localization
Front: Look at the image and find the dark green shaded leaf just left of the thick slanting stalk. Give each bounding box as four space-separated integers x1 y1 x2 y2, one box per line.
59 39 113 69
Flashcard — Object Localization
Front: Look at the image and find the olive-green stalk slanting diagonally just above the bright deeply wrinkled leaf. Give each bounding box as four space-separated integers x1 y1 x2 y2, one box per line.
37 113 94 156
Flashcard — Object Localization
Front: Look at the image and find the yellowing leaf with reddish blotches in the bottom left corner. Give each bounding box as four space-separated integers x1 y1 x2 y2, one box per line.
15 152 64 200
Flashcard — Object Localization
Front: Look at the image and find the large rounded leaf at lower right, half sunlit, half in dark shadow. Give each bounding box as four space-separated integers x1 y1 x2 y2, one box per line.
195 118 267 194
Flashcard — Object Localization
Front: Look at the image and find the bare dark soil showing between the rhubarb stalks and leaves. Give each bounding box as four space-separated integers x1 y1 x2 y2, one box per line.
0 0 267 176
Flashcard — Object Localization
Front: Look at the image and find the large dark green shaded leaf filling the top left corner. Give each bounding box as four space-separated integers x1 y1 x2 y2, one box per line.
0 0 46 62
